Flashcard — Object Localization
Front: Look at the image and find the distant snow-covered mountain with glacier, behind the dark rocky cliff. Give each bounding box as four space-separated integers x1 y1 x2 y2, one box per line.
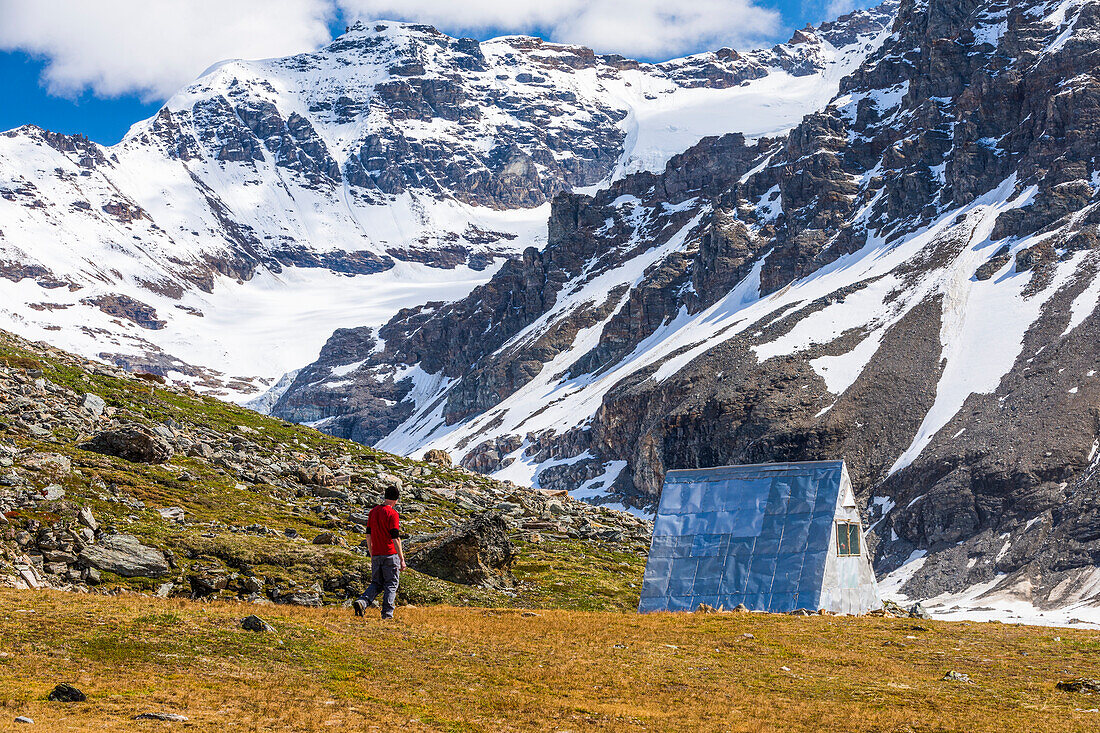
0 8 890 396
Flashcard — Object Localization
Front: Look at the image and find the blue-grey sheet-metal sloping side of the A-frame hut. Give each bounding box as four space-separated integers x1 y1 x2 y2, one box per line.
638 461 844 612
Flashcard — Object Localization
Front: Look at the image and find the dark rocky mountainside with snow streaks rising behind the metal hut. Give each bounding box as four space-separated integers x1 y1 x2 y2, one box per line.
276 0 1100 605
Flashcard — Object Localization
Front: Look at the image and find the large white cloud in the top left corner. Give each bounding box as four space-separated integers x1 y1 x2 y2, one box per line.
0 0 332 100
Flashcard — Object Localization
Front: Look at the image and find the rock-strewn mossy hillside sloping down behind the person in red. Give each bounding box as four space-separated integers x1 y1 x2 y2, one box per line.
0 332 650 605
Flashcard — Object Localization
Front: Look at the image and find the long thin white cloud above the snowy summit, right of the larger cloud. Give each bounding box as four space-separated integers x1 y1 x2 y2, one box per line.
336 0 780 58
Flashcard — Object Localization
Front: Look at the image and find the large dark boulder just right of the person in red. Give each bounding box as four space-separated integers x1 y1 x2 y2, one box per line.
407 512 516 587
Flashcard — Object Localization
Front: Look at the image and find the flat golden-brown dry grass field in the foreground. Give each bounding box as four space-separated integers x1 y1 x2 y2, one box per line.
0 591 1100 732
